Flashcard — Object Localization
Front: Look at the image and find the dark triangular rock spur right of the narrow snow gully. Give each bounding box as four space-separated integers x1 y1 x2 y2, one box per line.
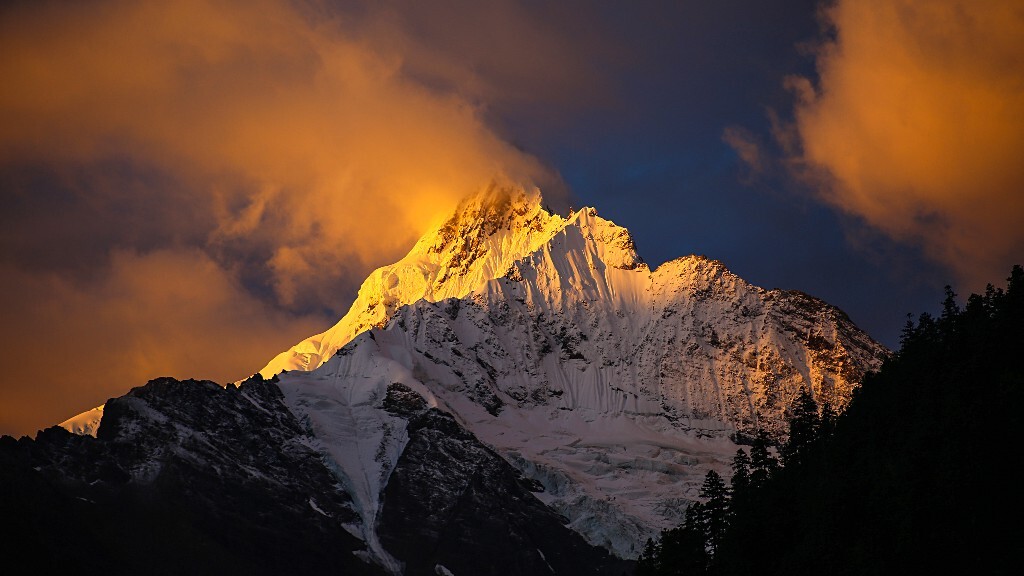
378 393 627 576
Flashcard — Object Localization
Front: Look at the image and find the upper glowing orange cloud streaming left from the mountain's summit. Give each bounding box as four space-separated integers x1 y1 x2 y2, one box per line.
0 0 557 304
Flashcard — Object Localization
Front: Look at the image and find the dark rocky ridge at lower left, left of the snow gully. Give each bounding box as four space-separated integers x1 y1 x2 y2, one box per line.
0 378 383 575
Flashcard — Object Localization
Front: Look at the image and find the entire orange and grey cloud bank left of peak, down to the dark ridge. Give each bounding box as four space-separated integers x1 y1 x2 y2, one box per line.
0 0 578 434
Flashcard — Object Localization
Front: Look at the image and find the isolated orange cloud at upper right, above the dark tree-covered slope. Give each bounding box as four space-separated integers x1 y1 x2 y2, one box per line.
780 0 1024 289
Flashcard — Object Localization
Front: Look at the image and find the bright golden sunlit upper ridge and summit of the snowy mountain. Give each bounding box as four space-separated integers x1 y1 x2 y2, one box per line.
260 182 642 377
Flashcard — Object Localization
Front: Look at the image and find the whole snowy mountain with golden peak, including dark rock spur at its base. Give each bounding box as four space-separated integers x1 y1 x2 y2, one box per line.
51 183 888 573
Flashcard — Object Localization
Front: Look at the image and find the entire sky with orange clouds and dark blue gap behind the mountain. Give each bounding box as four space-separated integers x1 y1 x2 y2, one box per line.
0 0 1024 435
